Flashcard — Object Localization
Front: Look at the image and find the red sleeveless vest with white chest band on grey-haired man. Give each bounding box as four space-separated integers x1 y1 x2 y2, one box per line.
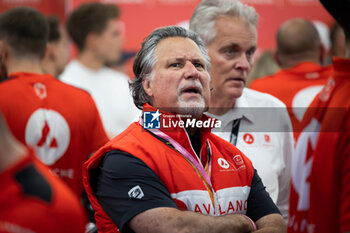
83 106 254 232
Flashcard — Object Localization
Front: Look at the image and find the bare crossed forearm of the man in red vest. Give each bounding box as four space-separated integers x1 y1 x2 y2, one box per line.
129 208 253 233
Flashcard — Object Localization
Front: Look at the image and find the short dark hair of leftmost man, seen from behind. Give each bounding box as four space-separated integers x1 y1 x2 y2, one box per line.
0 7 49 58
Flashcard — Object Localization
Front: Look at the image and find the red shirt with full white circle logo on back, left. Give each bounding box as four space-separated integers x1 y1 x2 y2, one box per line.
0 73 108 196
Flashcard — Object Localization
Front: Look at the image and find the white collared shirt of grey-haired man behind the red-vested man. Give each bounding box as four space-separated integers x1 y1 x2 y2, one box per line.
207 88 294 220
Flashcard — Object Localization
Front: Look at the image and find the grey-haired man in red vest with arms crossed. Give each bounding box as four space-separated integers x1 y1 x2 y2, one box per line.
83 27 286 233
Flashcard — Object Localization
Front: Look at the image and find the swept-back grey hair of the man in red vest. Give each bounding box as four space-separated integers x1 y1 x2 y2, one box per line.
130 26 210 109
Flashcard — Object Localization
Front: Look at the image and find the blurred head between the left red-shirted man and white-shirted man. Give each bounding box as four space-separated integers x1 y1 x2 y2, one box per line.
41 16 69 78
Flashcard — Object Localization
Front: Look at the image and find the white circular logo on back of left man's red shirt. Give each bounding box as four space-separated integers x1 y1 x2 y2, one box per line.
25 108 70 165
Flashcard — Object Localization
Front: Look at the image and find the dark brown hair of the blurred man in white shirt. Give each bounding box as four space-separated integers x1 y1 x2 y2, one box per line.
67 2 119 51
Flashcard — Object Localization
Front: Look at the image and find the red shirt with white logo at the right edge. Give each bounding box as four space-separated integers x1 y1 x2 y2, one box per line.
288 58 350 233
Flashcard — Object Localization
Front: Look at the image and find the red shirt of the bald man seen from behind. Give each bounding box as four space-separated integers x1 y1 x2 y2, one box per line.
250 62 331 132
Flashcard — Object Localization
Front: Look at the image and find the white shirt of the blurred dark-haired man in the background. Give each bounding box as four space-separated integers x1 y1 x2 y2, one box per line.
59 60 141 138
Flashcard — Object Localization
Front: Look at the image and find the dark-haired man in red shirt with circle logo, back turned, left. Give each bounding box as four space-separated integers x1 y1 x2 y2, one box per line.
0 7 108 200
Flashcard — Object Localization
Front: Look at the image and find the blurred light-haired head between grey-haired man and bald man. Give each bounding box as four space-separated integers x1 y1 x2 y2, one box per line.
246 50 280 87
